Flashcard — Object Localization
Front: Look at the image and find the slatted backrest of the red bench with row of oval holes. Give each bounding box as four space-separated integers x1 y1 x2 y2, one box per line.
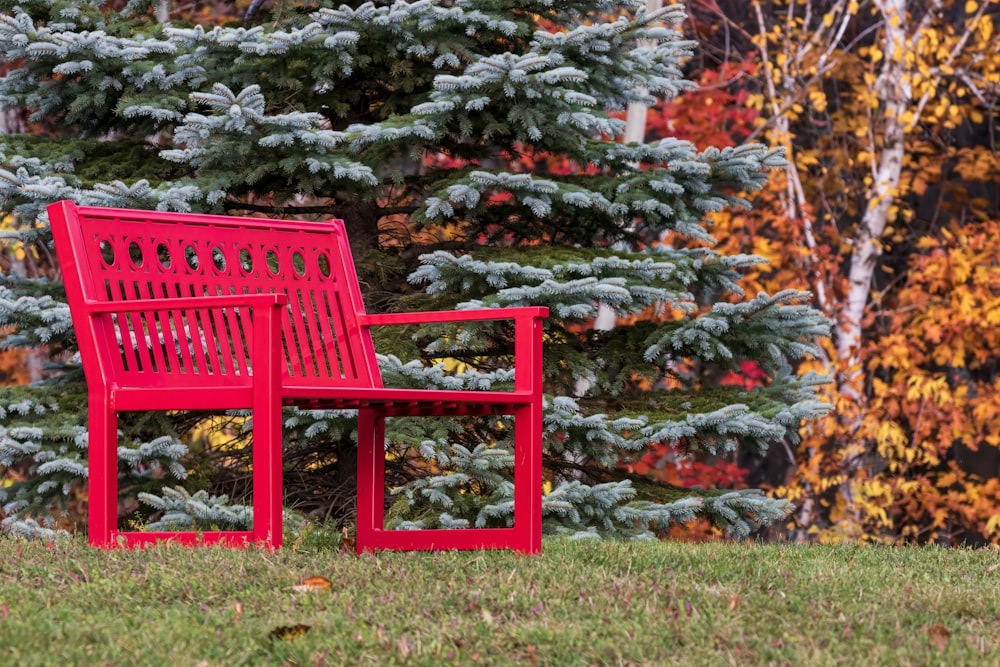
48 201 382 394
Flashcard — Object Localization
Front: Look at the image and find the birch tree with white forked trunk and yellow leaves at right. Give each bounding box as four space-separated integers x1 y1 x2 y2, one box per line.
693 0 1000 535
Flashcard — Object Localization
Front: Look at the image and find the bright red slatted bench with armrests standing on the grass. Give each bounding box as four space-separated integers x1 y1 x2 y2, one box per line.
48 201 547 553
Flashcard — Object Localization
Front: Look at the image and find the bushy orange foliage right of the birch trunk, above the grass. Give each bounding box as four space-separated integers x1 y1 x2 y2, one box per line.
861 221 1000 541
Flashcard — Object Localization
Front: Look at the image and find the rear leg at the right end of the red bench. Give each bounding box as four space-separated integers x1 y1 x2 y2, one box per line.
355 409 385 554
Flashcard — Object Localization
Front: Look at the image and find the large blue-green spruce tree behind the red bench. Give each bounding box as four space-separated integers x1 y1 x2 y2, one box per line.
0 0 828 537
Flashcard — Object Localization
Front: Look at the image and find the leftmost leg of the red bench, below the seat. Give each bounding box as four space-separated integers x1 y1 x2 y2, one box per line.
87 394 118 549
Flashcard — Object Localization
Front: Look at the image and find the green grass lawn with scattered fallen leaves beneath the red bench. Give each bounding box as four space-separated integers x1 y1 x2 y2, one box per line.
0 539 1000 666
